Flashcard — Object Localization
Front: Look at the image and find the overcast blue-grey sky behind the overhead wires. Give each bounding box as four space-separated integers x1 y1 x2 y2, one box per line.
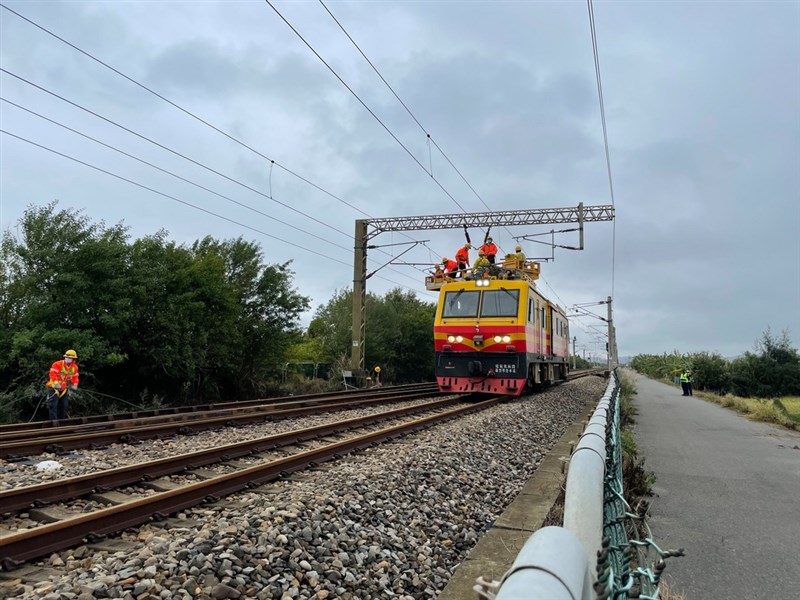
0 0 800 356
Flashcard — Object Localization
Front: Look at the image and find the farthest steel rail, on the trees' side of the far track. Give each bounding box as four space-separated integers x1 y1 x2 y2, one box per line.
0 383 437 432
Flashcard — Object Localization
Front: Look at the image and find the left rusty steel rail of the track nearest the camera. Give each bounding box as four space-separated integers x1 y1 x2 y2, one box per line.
0 397 464 513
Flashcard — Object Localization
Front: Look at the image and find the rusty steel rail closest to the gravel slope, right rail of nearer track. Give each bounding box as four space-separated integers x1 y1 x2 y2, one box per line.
0 397 503 569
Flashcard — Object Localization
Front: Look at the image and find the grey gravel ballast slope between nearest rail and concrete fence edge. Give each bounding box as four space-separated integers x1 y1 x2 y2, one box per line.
0 377 606 600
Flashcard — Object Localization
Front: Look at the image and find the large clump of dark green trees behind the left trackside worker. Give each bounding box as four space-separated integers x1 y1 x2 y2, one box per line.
0 203 308 420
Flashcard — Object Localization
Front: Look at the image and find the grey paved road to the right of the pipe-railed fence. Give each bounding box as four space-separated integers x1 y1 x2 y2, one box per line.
636 375 800 600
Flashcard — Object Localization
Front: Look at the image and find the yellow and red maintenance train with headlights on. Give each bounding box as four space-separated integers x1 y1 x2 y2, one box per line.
427 259 570 396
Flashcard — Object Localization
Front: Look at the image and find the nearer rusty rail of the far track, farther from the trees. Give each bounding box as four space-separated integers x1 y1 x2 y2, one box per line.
0 391 441 460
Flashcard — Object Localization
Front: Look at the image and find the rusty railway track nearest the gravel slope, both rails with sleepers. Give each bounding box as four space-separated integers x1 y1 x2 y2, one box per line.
0 397 503 570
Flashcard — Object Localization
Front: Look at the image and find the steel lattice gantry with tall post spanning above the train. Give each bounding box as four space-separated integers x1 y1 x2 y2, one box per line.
350 203 614 374
